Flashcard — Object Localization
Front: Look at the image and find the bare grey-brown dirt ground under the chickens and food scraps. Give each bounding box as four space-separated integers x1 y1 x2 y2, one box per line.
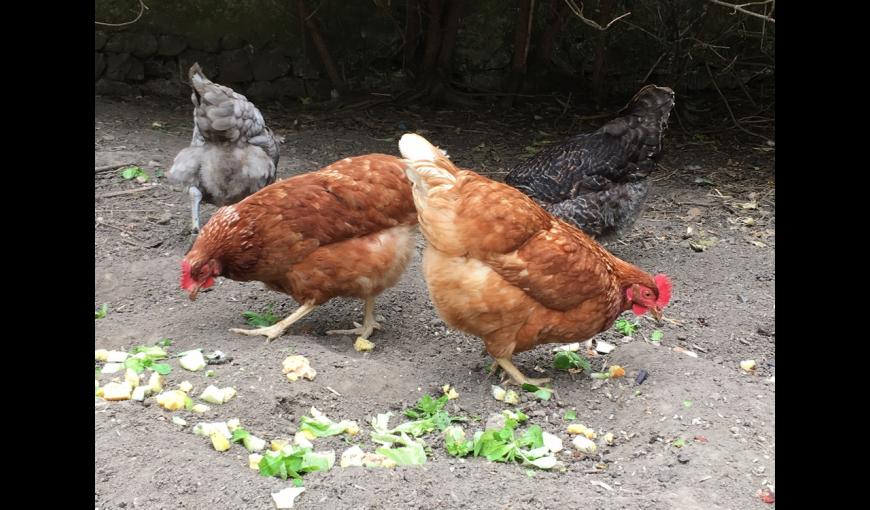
94 93 776 510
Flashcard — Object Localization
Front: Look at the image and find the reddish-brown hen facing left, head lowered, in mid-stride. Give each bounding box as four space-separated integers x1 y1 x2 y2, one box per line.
181 154 417 341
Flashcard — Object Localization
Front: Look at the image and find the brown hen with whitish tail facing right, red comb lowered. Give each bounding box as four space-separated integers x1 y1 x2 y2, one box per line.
399 134 671 383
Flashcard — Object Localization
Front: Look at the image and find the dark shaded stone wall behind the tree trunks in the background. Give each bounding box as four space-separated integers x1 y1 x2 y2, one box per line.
94 0 773 101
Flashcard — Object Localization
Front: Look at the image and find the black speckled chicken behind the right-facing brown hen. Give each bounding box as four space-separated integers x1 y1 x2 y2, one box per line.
505 85 674 241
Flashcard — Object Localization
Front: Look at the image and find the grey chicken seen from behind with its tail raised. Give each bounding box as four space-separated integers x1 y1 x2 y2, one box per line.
166 64 278 232
